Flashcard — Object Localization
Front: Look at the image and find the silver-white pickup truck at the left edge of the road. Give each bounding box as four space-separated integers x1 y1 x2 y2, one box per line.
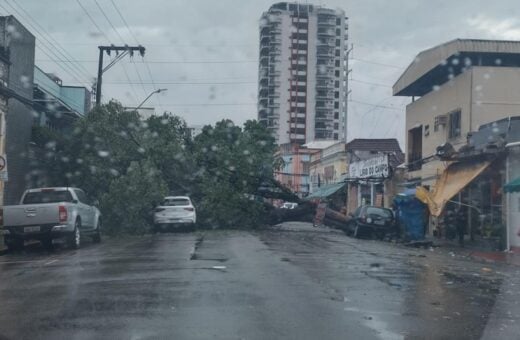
0 187 101 249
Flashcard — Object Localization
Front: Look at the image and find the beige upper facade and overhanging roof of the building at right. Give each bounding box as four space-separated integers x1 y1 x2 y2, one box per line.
393 40 520 186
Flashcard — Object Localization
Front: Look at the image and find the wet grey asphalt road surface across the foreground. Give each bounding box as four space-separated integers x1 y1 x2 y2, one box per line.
0 223 520 339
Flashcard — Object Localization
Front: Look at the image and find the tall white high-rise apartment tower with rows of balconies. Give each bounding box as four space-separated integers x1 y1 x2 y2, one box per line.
258 2 348 144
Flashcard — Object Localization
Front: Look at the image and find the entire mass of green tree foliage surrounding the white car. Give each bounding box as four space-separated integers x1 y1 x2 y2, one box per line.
38 101 279 234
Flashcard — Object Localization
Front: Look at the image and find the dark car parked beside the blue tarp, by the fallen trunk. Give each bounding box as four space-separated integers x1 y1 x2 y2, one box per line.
346 205 396 239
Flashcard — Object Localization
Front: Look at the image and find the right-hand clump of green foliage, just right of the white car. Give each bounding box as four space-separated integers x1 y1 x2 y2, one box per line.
193 120 276 228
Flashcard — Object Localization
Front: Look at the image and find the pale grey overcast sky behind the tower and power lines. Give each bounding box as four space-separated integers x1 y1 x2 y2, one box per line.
6 0 520 146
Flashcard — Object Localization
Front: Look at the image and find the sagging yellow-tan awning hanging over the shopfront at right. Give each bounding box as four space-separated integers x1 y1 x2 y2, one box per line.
415 161 491 216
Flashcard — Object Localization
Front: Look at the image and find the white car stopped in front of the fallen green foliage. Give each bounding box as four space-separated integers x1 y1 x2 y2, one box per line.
153 196 197 231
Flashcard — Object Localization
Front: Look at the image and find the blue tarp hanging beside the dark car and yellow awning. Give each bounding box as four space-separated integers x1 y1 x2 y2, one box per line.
394 189 428 241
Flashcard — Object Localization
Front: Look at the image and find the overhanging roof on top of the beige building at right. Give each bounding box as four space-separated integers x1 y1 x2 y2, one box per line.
393 39 520 96
